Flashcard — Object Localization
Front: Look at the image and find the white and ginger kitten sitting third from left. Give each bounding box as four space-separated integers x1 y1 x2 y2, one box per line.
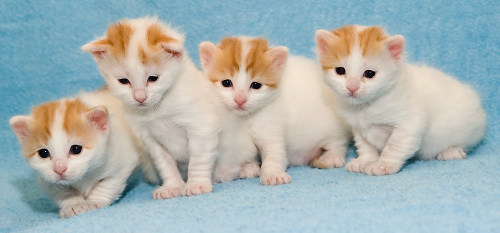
199 37 350 185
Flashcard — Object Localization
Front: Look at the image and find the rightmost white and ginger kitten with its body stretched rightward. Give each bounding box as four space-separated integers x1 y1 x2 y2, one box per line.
316 26 486 175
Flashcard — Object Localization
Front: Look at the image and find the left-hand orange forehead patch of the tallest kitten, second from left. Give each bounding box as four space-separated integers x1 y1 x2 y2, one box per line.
102 22 133 58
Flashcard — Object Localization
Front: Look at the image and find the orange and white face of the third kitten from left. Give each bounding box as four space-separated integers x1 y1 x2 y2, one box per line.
200 38 288 115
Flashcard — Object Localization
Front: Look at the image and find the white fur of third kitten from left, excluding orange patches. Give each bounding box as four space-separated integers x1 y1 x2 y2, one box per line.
200 38 349 185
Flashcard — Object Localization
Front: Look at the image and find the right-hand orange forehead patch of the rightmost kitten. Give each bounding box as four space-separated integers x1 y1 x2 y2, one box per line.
358 27 387 56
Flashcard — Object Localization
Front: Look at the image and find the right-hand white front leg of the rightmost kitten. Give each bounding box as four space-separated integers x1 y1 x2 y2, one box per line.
365 117 425 175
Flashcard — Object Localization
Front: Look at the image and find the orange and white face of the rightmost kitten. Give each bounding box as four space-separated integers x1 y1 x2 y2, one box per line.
316 26 404 104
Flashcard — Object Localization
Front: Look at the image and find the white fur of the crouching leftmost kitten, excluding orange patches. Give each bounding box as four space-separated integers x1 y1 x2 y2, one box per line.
11 91 143 218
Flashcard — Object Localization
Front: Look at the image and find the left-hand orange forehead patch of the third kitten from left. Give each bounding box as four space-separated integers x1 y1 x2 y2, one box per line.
208 37 243 82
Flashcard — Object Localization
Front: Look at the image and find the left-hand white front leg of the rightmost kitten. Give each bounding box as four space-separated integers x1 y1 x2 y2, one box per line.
345 129 378 172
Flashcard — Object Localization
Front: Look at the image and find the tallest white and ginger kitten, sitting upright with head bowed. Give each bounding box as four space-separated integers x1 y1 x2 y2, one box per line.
82 17 220 199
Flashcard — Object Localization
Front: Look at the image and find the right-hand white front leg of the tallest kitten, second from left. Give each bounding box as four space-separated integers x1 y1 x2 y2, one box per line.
184 132 215 196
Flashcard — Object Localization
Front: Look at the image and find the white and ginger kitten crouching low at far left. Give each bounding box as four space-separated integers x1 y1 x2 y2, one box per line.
10 91 148 218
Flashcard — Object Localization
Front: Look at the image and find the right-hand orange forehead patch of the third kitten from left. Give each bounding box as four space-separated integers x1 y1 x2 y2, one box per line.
246 38 280 88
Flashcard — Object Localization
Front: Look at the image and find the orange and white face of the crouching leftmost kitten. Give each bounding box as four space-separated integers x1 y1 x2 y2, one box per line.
10 99 108 185
